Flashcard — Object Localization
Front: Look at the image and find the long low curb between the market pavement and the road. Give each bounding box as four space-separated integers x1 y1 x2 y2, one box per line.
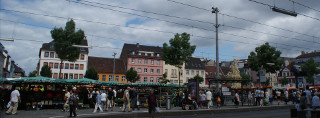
79 105 294 118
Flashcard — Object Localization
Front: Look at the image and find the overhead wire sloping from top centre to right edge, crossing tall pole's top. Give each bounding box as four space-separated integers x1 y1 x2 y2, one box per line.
167 0 319 38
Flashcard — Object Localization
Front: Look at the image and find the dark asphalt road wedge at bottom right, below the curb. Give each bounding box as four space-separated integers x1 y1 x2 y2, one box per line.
160 109 290 118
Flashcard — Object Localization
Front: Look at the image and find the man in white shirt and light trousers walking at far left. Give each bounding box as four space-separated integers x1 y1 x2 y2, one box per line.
6 87 21 115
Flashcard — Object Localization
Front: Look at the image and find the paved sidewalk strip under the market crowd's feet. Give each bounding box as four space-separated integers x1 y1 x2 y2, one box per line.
0 103 293 118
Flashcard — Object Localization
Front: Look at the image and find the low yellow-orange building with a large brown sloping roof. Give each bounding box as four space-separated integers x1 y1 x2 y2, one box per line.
88 56 127 83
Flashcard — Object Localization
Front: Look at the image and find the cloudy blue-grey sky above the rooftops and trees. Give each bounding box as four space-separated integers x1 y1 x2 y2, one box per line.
0 0 320 73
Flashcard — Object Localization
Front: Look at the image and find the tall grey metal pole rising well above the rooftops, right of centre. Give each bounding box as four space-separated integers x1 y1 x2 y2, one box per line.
212 7 220 92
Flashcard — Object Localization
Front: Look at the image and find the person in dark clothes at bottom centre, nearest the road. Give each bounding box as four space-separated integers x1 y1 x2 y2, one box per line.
147 90 157 118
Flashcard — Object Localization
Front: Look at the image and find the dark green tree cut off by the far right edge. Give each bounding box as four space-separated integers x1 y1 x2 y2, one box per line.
301 58 320 85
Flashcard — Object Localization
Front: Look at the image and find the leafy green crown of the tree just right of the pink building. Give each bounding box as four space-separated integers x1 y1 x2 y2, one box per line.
162 32 196 68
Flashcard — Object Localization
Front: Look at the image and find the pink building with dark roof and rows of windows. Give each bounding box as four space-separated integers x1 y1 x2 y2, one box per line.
120 43 163 83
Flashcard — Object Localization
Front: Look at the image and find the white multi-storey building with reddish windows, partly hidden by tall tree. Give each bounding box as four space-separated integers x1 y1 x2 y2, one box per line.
37 39 89 79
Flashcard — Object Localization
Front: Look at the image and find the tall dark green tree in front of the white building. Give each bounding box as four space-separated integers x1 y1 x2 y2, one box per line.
50 19 85 77
